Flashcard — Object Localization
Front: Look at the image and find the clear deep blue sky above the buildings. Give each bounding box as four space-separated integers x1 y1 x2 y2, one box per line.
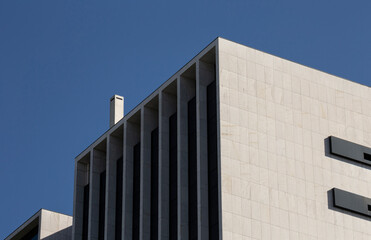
0 0 371 238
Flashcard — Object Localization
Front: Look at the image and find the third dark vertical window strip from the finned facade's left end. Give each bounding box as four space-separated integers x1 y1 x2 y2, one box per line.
115 157 123 240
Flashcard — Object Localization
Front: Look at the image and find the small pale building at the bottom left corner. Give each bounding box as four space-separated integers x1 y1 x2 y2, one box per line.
5 209 72 240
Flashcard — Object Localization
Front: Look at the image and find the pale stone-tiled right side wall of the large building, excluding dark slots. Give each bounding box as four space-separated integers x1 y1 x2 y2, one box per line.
218 39 371 240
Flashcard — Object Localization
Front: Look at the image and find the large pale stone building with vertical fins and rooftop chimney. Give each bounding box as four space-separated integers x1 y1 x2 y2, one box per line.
72 38 371 240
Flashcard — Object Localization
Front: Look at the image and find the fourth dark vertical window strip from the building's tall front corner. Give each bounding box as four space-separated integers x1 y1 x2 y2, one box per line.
151 128 158 240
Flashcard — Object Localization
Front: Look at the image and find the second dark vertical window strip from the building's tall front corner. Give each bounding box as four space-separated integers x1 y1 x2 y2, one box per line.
188 98 198 240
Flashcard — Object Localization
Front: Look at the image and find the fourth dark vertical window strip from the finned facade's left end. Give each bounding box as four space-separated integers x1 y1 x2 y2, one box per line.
133 143 140 240
